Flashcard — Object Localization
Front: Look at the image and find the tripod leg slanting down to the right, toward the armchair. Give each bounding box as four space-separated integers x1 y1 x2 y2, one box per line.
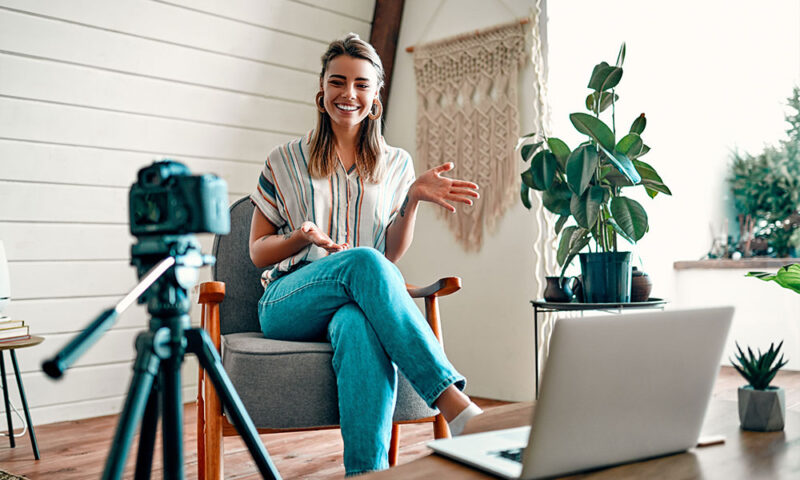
185 328 281 480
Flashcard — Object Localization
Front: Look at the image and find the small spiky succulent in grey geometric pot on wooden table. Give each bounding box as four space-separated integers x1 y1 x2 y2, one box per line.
731 342 787 432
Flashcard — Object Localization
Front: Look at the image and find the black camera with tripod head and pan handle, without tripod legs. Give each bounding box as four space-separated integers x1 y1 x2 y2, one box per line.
42 160 230 378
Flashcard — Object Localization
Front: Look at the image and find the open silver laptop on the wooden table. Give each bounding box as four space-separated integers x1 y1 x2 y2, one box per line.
428 307 733 479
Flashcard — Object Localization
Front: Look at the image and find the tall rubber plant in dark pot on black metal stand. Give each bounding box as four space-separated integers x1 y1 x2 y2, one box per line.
520 43 671 302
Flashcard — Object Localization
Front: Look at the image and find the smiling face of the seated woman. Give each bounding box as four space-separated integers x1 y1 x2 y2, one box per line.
322 55 378 128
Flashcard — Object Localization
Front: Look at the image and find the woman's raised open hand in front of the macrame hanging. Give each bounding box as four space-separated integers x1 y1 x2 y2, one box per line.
408 162 480 212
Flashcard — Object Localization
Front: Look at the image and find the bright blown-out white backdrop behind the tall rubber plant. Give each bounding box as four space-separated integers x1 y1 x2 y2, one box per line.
548 0 800 300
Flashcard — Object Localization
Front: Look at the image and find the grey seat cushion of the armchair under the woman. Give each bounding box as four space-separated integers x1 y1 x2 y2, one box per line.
222 332 438 428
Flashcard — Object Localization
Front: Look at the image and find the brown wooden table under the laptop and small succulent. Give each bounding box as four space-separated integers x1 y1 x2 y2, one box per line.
364 400 800 480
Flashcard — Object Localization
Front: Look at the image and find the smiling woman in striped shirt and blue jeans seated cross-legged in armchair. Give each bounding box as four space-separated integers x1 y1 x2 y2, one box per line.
250 34 481 476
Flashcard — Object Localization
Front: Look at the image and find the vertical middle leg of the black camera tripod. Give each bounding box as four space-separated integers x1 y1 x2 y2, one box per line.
160 356 183 480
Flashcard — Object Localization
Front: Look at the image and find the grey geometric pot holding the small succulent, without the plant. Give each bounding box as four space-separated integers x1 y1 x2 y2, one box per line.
739 385 786 432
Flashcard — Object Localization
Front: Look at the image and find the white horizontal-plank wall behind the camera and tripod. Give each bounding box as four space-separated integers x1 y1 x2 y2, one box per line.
0 0 374 424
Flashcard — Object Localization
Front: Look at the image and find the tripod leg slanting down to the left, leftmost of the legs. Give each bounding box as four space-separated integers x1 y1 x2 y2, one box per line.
102 332 161 480
